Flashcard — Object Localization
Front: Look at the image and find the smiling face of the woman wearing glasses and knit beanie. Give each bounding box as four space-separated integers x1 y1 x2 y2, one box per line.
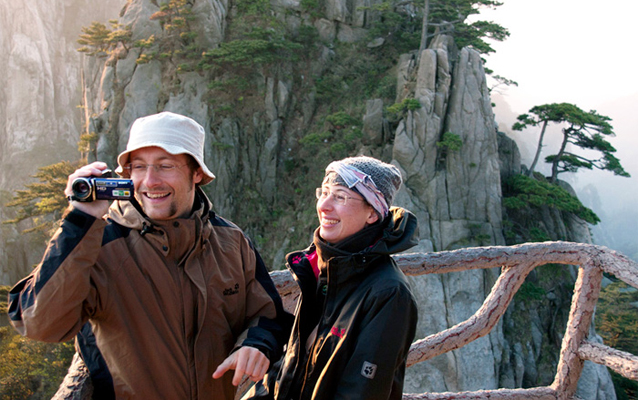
317 184 379 243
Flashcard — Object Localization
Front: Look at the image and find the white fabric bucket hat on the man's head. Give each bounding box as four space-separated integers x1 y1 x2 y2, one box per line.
115 111 215 185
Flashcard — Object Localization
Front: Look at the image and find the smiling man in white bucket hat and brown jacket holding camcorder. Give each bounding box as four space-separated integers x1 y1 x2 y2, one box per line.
9 112 290 400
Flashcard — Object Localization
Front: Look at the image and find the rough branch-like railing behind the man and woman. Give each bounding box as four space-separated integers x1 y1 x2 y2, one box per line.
54 242 638 400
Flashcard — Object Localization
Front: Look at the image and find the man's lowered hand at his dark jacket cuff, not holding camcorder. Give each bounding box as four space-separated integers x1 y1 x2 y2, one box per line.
213 346 270 386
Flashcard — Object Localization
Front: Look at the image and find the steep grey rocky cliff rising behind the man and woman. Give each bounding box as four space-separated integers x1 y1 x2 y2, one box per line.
0 0 615 400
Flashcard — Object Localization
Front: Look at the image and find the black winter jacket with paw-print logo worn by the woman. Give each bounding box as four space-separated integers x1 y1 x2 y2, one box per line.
245 207 417 400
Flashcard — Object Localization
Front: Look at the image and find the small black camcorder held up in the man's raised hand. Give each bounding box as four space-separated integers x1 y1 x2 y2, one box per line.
69 169 133 203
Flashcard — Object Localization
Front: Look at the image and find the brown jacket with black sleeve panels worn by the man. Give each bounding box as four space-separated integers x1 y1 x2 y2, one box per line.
9 191 287 400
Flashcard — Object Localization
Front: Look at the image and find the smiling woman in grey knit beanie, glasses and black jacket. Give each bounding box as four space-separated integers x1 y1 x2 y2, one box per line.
244 157 418 400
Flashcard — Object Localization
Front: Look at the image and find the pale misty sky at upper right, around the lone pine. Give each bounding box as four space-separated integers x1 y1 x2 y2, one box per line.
480 0 638 253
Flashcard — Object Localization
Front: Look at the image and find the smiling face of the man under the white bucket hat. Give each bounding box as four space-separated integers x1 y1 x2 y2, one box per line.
129 147 203 221
